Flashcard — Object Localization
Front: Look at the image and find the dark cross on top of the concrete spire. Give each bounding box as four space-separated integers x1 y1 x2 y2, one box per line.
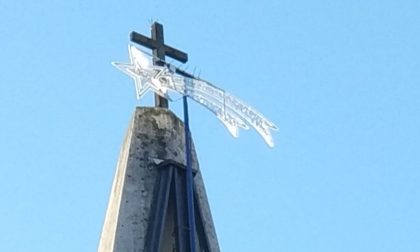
130 22 188 108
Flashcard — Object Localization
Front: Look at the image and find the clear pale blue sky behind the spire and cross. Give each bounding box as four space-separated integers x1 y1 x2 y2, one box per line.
0 0 420 252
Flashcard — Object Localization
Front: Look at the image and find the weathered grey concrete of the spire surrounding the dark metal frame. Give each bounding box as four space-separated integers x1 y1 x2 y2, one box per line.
98 107 220 252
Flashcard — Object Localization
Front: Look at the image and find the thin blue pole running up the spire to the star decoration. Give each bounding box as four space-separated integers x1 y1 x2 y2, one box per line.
183 95 195 252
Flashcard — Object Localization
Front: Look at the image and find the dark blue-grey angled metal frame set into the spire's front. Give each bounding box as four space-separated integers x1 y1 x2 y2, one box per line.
145 160 210 252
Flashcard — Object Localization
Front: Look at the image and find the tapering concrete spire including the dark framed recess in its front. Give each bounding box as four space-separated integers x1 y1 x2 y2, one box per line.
98 107 220 252
